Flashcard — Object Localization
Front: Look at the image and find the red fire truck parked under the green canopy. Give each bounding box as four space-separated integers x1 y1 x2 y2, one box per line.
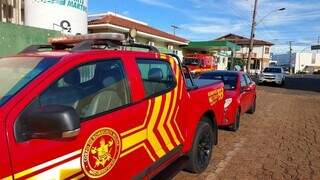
183 54 217 75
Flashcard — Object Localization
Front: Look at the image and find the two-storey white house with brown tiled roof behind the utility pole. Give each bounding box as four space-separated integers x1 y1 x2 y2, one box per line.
216 34 273 73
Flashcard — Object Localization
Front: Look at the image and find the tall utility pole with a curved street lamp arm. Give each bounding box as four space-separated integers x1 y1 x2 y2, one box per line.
247 0 286 73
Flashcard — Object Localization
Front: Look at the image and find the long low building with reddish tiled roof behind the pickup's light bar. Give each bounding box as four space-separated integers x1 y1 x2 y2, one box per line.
88 12 188 59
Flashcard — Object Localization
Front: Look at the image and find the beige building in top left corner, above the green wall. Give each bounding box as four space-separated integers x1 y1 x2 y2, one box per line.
0 0 24 24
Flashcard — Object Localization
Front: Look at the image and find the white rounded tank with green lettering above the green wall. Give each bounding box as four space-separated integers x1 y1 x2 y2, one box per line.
24 0 88 34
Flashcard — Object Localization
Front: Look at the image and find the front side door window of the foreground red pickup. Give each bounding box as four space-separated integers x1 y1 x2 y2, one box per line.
39 60 130 119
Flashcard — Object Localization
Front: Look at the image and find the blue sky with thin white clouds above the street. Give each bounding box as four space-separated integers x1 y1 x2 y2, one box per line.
132 0 320 53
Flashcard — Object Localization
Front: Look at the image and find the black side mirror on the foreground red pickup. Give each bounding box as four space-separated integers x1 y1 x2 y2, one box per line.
15 105 80 141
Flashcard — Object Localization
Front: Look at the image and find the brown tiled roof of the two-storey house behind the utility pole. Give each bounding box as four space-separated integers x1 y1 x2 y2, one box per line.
215 34 273 46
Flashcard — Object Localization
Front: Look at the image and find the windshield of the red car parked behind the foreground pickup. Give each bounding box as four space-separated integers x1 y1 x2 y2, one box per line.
199 73 237 90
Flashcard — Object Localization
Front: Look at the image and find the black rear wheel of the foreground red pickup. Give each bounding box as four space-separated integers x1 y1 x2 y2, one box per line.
185 117 214 174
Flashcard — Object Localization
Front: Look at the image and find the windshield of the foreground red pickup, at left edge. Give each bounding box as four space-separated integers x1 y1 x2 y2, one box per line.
0 57 57 106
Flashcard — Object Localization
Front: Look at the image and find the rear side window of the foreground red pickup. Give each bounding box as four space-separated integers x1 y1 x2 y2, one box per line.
137 59 176 97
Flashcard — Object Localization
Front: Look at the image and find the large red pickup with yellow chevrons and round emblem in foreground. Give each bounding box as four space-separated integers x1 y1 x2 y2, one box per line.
0 34 224 179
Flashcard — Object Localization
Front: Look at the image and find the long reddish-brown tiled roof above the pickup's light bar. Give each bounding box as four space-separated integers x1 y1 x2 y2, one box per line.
88 13 188 43
